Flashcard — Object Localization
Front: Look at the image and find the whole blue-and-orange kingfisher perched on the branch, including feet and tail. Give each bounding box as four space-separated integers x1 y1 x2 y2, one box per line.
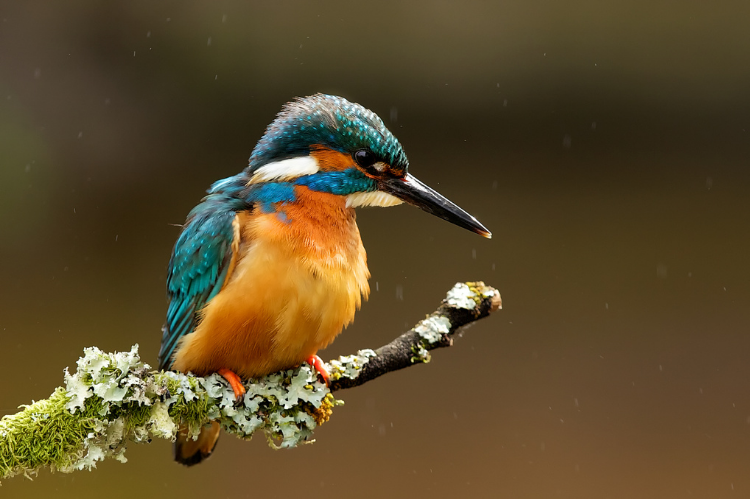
159 94 491 466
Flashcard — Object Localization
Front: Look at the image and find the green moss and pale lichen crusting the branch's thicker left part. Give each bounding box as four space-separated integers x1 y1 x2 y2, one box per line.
0 345 356 478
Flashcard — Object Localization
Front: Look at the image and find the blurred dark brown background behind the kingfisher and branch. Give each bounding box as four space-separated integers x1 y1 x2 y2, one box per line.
0 0 750 498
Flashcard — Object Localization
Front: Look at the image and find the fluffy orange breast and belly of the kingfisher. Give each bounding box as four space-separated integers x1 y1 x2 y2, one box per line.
174 187 370 377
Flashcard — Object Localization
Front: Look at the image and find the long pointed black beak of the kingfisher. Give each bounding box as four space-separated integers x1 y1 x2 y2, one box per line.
380 173 492 239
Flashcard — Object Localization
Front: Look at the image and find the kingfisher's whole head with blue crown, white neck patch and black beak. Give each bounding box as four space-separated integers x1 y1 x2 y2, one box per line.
246 94 491 238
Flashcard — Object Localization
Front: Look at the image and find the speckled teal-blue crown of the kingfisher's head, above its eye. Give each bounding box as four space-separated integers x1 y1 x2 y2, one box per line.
247 94 409 173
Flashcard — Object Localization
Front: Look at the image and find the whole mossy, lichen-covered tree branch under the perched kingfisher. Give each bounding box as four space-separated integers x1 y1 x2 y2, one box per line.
0 282 501 478
